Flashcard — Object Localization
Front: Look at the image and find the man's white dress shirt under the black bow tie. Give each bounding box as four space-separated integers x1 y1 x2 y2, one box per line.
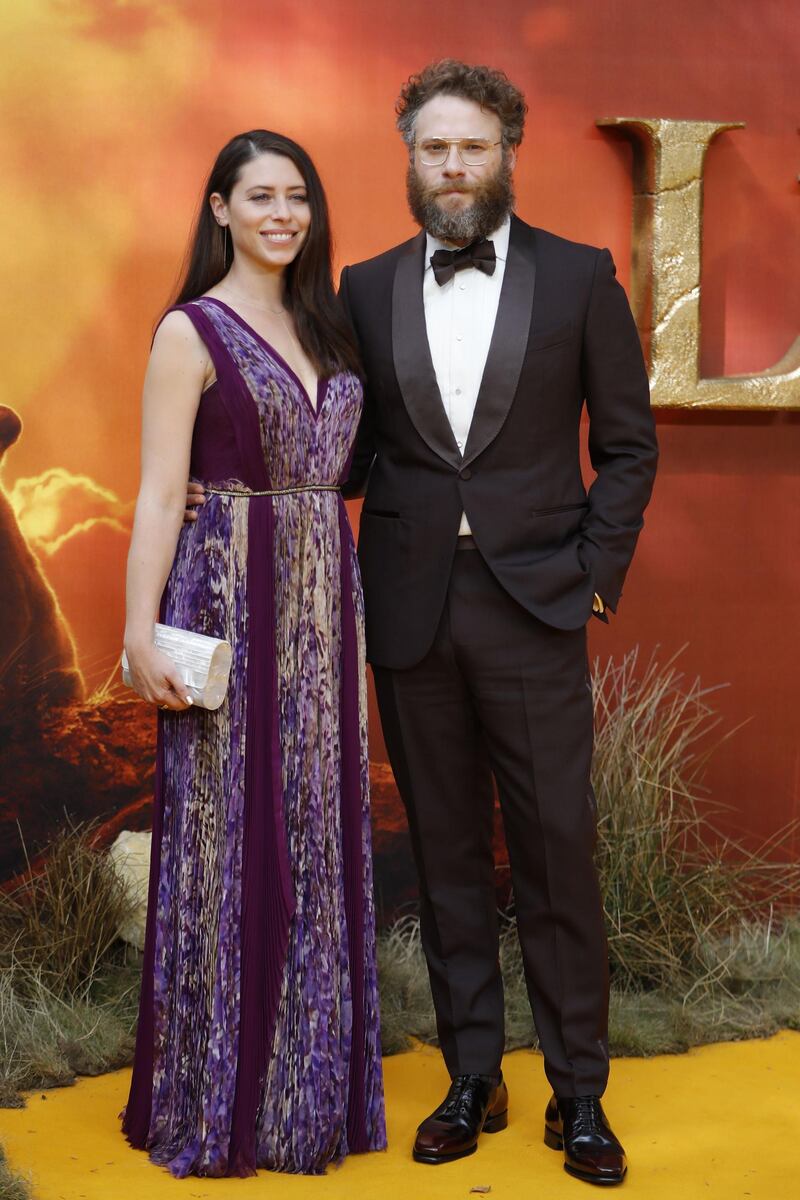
422 218 511 534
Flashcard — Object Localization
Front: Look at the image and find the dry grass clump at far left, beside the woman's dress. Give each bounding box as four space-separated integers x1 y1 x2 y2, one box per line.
0 826 140 1105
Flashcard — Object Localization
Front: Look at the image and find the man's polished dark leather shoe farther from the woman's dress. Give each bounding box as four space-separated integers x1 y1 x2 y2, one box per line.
545 1096 627 1184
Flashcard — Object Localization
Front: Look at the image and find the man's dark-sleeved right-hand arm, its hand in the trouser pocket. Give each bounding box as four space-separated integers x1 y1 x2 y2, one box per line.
581 250 658 611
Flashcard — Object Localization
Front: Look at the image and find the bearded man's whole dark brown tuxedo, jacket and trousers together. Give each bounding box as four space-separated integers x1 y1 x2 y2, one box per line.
341 217 657 1097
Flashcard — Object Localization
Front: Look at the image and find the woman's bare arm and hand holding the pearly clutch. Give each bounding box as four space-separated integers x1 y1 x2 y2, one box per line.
125 312 212 709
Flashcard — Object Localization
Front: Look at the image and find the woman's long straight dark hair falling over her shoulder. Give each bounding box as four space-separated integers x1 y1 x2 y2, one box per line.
173 130 361 376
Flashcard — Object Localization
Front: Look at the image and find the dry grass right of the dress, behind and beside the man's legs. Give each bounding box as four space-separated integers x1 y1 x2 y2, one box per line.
379 650 800 1055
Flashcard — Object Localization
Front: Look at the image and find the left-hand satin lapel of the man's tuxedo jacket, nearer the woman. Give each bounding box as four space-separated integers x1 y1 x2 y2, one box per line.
392 233 462 467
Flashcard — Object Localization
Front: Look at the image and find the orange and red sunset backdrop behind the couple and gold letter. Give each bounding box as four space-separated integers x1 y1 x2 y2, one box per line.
0 0 800 873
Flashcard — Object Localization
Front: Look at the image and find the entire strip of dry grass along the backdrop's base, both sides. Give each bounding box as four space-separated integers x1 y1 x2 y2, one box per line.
0 652 800 1123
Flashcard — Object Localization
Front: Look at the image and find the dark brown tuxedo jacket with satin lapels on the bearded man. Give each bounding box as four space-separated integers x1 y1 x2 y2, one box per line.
341 217 657 668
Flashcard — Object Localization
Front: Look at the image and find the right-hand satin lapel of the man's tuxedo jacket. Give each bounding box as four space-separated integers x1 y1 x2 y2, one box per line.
463 217 536 466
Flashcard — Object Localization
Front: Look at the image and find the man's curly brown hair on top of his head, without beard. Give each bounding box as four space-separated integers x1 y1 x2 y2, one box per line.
395 59 528 149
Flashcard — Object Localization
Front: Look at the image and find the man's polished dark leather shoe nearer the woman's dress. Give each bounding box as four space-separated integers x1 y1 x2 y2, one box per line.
414 1075 509 1164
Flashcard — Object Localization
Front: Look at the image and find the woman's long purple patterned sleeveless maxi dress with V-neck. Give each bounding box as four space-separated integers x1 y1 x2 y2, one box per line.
122 296 386 1176
